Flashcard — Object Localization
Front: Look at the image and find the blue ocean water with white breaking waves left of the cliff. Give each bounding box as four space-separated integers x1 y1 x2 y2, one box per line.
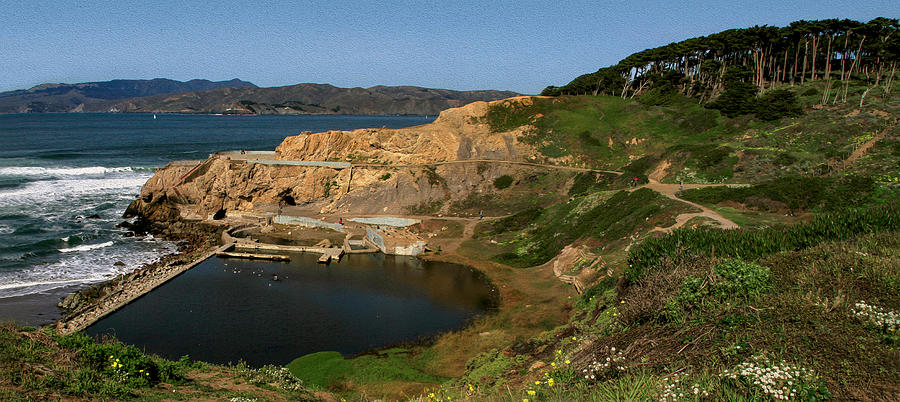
0 114 433 325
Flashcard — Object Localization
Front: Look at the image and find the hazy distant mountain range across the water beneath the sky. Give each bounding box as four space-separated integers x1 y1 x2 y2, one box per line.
0 79 518 115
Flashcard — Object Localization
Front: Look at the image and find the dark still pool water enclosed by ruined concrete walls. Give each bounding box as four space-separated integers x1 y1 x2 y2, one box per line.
86 254 496 366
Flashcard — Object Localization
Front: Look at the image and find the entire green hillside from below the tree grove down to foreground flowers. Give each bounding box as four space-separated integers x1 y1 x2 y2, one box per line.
422 82 900 401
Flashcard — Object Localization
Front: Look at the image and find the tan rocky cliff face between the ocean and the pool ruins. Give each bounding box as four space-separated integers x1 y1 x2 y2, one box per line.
129 97 535 221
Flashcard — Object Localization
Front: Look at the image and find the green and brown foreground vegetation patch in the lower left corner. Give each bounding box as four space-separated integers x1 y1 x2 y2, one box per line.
0 324 319 401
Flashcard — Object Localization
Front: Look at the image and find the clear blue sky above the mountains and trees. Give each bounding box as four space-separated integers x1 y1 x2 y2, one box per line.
0 0 900 93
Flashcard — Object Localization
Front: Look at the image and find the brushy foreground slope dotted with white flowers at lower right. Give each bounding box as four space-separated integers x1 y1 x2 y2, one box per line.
442 225 900 400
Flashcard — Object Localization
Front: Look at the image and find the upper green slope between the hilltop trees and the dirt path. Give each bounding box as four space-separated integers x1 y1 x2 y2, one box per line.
484 81 900 187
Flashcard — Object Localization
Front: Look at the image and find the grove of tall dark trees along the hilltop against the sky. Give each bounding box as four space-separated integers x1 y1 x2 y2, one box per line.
545 17 900 107
